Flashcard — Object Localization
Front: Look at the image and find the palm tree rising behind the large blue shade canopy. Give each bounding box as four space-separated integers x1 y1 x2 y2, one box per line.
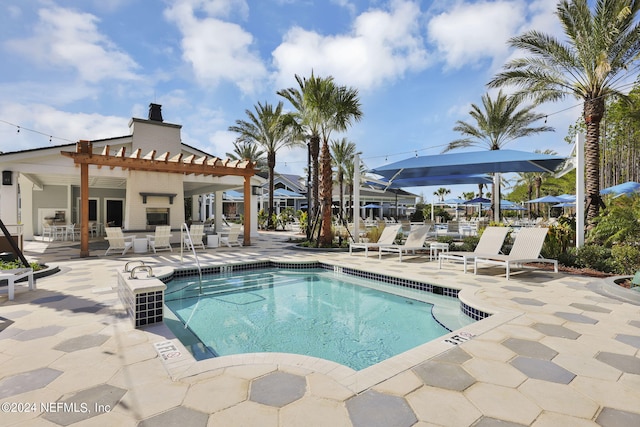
444 90 554 221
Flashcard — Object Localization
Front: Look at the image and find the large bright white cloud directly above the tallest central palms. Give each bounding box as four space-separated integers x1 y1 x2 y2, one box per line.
272 1 429 89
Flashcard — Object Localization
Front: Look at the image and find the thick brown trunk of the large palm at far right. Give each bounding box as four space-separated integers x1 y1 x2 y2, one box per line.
584 98 605 229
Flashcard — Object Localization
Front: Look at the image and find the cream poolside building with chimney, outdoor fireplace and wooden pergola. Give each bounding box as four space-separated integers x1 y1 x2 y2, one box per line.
0 104 264 254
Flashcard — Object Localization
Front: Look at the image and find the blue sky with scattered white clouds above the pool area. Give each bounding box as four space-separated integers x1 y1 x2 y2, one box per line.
0 0 596 200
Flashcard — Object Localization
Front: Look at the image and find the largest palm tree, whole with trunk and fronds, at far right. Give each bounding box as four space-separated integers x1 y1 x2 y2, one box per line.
489 0 640 226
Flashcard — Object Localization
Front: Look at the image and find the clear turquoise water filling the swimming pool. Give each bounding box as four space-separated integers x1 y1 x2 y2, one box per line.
165 269 458 370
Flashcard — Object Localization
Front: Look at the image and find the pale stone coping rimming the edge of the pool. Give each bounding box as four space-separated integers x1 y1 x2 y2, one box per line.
152 259 524 393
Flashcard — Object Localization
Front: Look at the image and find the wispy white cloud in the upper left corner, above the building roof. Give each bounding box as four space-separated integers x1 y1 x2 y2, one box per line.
6 7 138 83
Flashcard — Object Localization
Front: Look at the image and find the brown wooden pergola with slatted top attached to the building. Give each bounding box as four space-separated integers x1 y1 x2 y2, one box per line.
61 141 257 257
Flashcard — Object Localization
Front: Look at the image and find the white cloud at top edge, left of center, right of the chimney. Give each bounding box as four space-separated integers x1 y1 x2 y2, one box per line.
165 0 267 93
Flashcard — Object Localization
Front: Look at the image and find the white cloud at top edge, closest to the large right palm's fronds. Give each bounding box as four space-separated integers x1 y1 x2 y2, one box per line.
428 0 525 69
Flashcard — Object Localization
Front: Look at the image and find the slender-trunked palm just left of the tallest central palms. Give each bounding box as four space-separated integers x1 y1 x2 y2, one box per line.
229 102 300 228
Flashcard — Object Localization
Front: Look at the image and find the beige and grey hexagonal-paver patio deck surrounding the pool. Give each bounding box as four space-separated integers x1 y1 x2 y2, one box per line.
0 233 640 427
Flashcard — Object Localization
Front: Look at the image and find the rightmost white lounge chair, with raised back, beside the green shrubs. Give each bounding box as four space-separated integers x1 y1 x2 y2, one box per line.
473 227 558 280
